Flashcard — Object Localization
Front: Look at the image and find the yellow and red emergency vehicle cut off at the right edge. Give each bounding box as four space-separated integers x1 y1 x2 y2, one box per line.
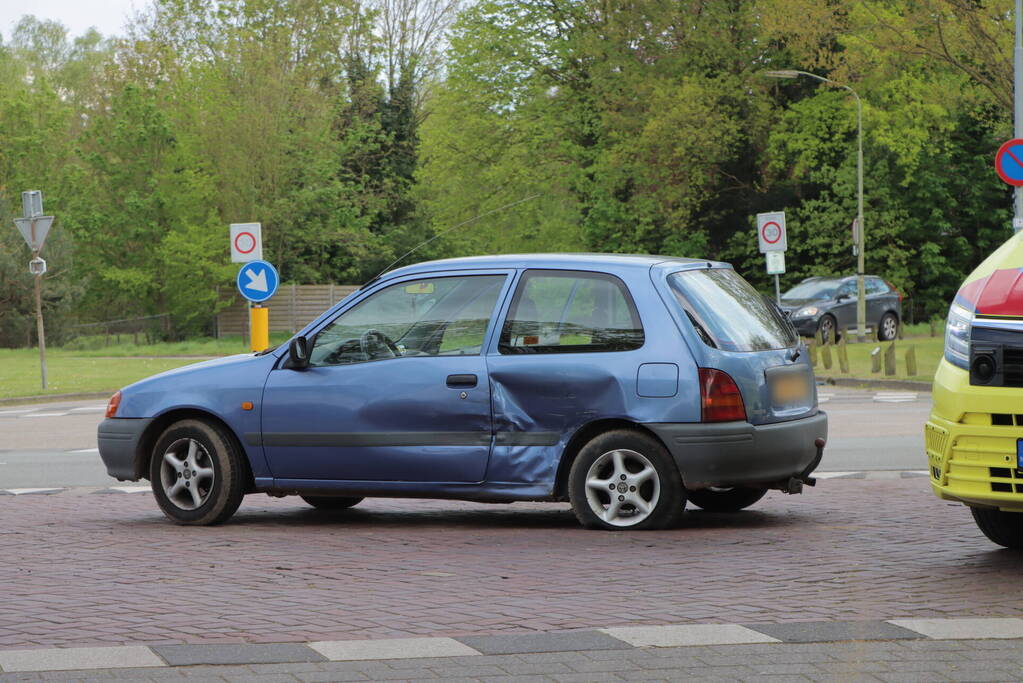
924 232 1023 548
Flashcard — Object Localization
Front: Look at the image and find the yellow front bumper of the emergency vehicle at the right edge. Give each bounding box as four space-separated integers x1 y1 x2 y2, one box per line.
924 359 1023 512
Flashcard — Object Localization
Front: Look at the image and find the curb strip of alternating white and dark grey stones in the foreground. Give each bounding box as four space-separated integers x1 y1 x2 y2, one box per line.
0 618 1023 673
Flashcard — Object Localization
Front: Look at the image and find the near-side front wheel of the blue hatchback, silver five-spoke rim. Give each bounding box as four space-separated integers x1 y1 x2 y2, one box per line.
149 419 247 527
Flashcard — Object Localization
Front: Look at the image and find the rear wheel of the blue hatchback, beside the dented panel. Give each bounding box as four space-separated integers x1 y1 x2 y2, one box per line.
569 429 685 531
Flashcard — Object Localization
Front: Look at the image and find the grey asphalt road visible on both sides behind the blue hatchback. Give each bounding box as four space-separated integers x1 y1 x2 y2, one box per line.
0 386 930 489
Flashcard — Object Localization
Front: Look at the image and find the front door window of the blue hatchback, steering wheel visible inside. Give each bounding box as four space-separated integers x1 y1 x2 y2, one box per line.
309 275 505 366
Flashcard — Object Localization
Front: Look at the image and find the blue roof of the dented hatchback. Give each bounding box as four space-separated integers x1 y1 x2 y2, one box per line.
381 254 727 279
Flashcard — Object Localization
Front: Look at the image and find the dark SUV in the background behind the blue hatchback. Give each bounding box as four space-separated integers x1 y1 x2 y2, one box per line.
782 275 902 342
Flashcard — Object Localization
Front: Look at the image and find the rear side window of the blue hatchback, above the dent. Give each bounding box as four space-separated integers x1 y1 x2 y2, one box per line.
498 270 643 354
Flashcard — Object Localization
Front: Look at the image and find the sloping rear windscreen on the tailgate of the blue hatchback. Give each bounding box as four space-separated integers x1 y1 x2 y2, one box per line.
668 268 799 351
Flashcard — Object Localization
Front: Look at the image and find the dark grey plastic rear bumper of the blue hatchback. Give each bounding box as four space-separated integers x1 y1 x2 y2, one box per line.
646 412 828 489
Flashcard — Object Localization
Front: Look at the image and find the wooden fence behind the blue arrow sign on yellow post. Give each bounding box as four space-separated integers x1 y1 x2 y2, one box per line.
217 284 359 337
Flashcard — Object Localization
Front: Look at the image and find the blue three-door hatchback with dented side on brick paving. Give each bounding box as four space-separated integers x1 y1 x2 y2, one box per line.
98 254 828 530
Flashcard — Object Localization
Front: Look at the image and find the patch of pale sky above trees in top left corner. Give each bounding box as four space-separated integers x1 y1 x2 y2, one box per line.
0 0 147 40
